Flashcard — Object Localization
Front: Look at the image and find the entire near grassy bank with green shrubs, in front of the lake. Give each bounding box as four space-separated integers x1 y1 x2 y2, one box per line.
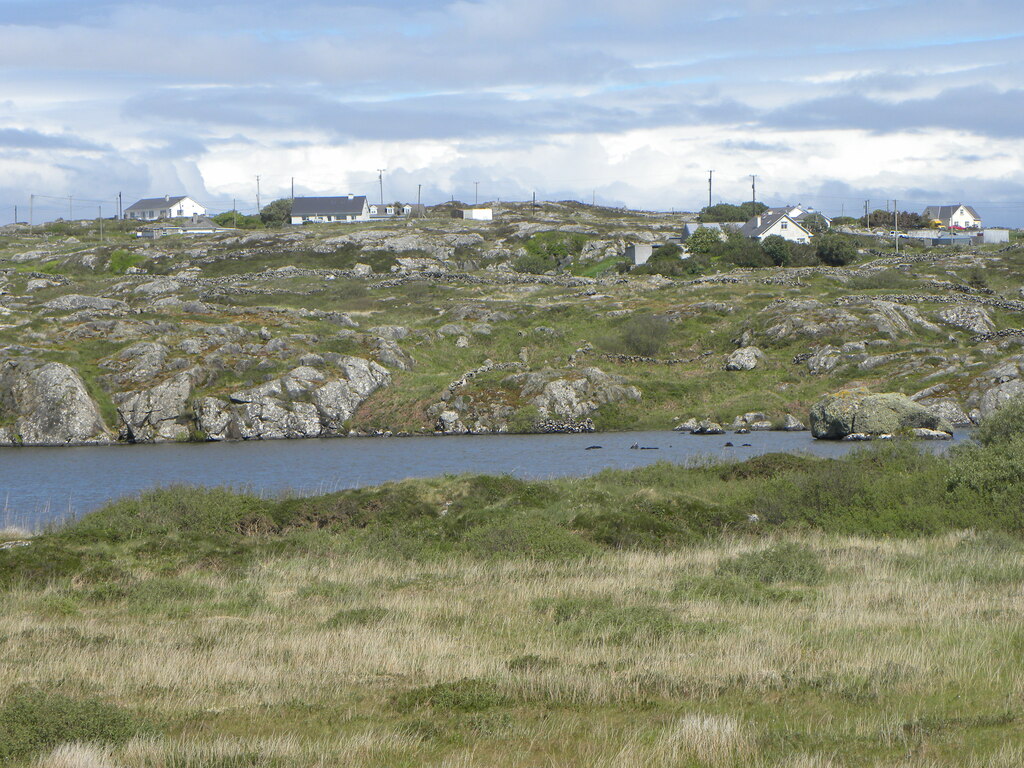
0 427 1024 768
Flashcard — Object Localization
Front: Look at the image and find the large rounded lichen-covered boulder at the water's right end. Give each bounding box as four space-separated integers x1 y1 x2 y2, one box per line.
811 389 953 440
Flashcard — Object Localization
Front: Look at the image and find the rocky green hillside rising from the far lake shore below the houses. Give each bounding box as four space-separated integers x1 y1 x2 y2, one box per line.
0 203 1024 444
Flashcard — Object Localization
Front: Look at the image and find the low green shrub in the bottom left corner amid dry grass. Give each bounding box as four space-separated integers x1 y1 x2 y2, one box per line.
0 688 143 765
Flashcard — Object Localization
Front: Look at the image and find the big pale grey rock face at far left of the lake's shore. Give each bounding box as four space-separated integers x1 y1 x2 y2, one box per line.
0 360 111 445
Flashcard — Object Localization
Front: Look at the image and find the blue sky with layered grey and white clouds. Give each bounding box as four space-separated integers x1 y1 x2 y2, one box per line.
0 0 1024 226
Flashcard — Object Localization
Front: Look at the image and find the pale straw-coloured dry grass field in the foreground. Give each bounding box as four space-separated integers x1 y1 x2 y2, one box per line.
6 534 1024 768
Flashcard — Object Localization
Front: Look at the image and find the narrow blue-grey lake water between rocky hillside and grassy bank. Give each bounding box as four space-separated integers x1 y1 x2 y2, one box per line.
0 430 969 528
